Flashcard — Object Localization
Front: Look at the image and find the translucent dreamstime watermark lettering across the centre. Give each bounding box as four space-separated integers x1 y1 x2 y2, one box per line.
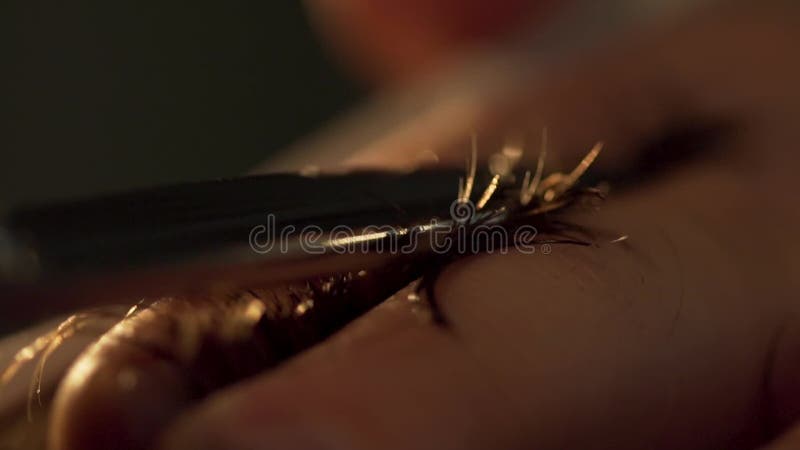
249 200 551 255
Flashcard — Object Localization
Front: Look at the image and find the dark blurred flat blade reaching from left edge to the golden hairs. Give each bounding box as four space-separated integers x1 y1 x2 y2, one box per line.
0 170 468 280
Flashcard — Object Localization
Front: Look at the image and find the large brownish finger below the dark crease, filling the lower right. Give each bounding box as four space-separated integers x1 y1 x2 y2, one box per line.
159 156 789 449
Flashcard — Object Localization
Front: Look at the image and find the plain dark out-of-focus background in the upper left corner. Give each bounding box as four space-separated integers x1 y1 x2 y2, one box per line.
0 0 361 212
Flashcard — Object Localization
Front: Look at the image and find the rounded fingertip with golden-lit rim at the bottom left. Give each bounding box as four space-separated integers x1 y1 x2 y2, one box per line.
48 343 191 450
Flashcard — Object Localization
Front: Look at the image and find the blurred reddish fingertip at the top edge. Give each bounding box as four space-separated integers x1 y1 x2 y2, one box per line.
307 0 555 82
